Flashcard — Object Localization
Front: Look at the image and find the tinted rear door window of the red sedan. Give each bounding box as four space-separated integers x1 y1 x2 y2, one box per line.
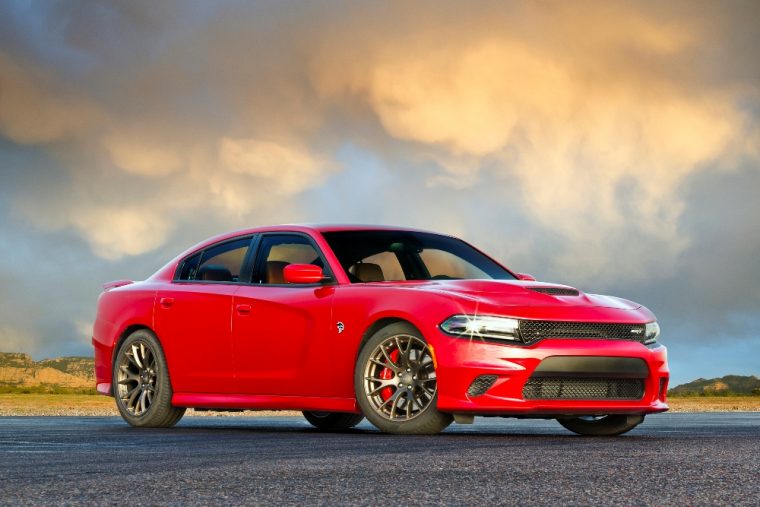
179 238 251 282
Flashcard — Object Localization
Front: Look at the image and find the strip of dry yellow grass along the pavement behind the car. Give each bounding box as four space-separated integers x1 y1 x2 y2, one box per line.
0 394 760 417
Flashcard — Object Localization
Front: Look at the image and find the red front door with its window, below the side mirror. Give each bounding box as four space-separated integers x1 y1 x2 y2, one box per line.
232 233 335 396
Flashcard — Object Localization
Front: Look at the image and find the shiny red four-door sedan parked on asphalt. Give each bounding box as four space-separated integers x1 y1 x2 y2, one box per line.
93 225 669 435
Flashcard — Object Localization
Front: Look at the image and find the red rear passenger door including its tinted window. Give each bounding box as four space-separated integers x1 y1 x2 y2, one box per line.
155 236 252 394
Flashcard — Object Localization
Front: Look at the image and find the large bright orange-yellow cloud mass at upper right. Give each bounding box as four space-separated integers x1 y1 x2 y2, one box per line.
312 3 748 279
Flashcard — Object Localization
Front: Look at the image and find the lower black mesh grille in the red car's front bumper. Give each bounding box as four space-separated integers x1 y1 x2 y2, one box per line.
523 377 644 400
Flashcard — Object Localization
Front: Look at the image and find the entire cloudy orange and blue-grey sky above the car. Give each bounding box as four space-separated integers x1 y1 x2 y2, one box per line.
0 0 760 383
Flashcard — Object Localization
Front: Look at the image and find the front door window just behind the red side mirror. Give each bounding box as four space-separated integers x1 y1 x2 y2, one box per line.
253 234 330 284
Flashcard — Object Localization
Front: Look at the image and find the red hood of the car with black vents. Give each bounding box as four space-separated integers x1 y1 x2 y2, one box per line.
384 280 641 310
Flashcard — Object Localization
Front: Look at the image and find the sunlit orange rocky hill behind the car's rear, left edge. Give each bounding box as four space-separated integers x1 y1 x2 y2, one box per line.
0 352 95 389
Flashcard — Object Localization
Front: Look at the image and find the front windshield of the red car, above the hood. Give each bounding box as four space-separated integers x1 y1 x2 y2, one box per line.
323 231 515 283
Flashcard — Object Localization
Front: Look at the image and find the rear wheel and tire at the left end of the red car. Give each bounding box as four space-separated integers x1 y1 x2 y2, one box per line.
113 329 185 428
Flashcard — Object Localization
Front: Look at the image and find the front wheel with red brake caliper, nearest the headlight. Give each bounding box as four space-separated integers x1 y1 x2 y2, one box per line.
354 322 453 435
